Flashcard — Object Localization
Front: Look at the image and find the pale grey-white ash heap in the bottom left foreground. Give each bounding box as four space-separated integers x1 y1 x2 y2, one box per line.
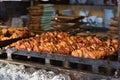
0 63 71 80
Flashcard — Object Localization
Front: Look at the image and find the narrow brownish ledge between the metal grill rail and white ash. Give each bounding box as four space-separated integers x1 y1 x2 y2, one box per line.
0 59 117 80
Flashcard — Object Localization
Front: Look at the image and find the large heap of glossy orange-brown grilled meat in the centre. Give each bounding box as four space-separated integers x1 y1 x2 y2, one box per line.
6 31 118 59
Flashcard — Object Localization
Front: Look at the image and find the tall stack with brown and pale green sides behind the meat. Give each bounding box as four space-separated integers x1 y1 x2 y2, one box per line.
28 4 56 30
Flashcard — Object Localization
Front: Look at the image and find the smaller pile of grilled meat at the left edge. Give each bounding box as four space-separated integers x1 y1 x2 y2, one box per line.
0 27 34 41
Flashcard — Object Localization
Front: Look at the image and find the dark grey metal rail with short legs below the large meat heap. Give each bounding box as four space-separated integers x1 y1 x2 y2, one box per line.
6 48 120 75
